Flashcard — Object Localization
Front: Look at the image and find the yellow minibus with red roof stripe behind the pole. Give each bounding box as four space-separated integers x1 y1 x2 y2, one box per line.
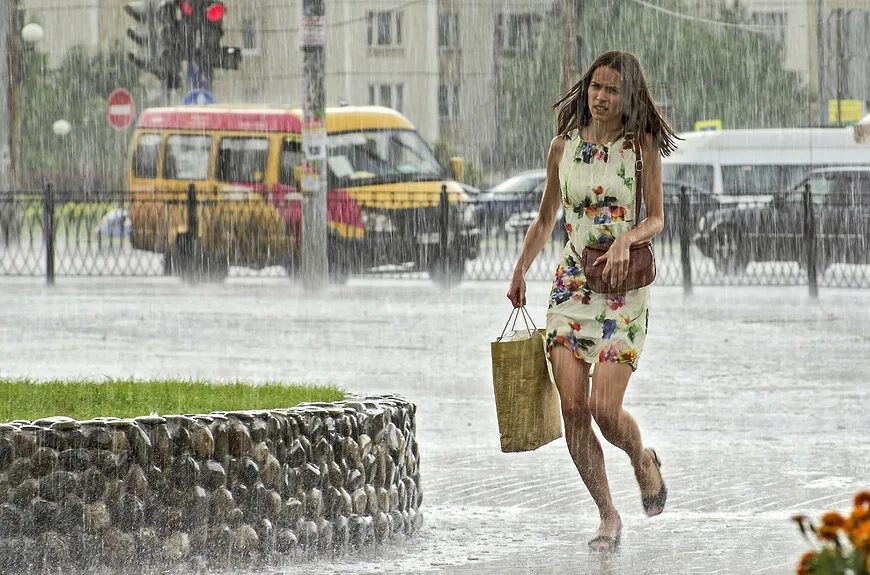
129 105 479 284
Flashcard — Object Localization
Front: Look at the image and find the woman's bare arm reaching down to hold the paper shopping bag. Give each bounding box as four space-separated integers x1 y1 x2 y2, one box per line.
507 136 565 307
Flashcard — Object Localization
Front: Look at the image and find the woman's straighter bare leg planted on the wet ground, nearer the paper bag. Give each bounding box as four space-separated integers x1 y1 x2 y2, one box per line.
550 347 622 537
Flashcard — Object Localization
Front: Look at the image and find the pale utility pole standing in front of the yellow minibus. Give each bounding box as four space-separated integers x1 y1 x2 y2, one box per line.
300 0 329 290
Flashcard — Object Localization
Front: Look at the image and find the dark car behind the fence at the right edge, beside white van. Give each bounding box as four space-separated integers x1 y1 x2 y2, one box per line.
697 167 870 273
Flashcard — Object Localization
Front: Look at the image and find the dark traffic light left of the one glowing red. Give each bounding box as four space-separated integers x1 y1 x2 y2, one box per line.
124 0 182 89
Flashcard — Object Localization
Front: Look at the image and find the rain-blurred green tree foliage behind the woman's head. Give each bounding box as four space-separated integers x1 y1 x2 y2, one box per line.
494 0 816 169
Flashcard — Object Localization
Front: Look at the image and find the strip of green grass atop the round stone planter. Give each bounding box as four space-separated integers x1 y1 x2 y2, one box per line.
0 378 345 421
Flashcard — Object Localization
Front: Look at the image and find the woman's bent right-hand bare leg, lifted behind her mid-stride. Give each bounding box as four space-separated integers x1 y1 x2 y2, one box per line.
590 363 662 510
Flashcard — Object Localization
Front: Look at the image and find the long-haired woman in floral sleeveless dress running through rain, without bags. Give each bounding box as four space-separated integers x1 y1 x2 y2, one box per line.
507 51 677 551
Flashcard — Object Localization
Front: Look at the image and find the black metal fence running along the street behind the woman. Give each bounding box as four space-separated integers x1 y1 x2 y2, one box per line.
0 187 870 294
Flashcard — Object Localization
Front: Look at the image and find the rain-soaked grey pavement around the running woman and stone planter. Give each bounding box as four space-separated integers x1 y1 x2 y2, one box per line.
0 277 870 575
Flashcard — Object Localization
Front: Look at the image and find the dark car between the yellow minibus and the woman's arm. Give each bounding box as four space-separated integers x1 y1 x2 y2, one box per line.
477 170 547 232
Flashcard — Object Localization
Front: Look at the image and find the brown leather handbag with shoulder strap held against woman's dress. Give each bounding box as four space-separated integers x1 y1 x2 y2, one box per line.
571 134 656 295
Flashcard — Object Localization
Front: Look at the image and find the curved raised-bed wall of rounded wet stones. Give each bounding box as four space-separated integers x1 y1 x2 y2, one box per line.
0 395 422 572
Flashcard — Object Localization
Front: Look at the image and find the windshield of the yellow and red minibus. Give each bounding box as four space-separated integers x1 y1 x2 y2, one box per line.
327 130 444 186
